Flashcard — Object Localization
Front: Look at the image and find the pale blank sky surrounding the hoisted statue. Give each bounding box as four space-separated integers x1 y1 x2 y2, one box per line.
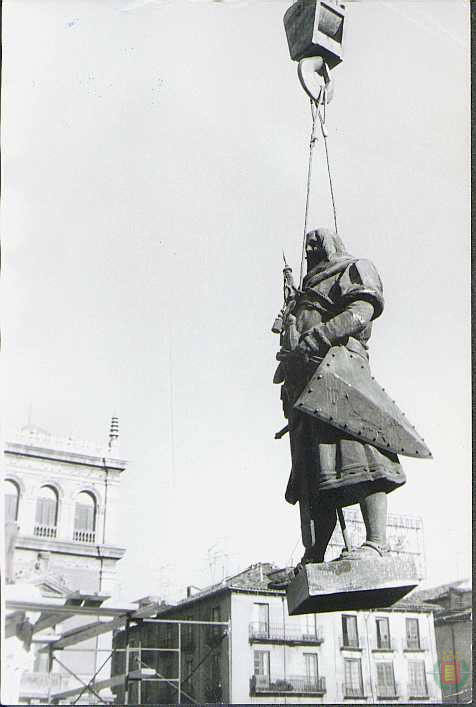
1 0 471 600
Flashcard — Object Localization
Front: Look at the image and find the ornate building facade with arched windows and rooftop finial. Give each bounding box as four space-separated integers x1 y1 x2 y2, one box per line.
3 418 126 704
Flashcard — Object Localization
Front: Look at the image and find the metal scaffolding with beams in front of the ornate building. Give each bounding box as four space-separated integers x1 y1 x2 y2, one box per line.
6 594 231 705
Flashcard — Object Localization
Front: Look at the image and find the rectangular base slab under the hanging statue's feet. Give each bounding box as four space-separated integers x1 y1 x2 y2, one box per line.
286 555 418 616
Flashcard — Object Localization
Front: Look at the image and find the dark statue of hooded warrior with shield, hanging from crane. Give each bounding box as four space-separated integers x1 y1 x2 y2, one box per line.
273 228 431 564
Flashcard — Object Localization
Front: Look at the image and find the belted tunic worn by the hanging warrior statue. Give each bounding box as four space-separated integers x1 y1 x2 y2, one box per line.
276 256 406 506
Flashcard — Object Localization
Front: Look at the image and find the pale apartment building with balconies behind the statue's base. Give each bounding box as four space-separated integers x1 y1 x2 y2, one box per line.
113 563 441 704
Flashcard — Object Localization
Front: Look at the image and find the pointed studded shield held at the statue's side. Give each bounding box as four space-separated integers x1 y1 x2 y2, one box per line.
294 346 431 458
